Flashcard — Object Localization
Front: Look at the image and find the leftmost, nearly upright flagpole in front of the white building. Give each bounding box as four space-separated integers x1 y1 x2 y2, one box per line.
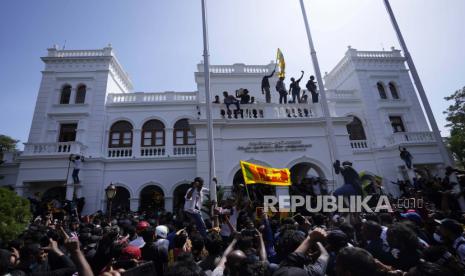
201 0 217 205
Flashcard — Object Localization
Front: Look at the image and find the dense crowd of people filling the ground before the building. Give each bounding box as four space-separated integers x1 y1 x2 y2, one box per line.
0 163 465 276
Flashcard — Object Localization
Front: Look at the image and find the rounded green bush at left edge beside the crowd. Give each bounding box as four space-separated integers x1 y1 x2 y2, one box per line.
0 188 32 241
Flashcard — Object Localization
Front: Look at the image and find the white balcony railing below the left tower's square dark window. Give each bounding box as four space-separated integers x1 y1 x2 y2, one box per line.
22 142 84 156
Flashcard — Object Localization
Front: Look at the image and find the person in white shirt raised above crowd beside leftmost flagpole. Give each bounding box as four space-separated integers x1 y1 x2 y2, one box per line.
184 177 208 237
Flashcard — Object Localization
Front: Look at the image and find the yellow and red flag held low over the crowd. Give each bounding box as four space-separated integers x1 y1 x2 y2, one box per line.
240 161 291 186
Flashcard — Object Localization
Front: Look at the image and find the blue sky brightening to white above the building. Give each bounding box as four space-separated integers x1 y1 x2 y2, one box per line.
0 0 465 149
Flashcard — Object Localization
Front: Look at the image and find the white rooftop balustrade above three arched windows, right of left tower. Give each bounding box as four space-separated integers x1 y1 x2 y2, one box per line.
107 92 197 105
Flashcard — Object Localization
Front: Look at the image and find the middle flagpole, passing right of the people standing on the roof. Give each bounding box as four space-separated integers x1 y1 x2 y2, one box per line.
300 0 339 175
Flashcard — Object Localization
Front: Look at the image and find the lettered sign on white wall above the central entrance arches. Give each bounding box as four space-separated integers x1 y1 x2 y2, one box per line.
237 140 312 153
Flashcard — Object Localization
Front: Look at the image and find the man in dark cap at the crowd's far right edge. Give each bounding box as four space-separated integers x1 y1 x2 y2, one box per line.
437 219 465 264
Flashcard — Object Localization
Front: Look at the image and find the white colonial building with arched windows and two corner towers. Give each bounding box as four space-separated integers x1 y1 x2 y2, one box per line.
0 46 442 213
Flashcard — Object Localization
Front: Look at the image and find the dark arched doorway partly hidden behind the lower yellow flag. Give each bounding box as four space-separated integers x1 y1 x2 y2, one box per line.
233 169 276 205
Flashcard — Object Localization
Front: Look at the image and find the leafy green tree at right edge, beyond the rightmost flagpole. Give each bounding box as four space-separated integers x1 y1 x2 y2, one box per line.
444 87 465 166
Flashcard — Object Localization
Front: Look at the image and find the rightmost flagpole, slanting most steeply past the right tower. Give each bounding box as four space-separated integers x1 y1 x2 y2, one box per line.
384 0 453 166
